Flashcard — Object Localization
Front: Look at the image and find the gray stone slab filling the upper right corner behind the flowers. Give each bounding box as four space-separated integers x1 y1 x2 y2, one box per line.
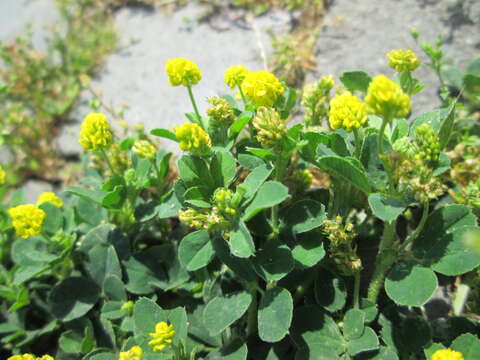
309 0 480 115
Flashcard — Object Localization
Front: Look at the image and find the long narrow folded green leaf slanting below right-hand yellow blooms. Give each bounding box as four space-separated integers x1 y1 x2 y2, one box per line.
317 156 371 194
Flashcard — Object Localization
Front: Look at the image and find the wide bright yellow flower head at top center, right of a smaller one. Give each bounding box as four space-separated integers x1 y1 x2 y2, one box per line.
241 70 285 106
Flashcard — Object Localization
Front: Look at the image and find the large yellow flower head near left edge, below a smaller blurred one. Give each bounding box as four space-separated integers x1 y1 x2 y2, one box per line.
8 204 46 239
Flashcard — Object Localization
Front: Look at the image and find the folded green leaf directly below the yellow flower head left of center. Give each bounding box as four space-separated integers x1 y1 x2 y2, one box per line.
178 155 214 190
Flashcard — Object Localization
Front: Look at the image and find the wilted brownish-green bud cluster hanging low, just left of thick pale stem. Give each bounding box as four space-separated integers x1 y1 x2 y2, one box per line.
322 216 362 276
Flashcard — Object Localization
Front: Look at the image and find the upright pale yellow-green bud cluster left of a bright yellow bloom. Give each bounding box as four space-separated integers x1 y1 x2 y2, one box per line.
302 75 335 126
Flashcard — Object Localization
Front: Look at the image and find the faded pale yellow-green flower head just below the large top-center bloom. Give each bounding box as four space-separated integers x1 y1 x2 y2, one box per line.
253 106 287 148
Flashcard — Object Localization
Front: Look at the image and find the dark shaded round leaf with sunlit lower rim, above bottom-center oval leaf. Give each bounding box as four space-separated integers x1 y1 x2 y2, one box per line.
254 240 294 281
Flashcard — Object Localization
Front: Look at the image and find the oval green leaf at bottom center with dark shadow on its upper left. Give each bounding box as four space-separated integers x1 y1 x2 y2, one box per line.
258 287 293 342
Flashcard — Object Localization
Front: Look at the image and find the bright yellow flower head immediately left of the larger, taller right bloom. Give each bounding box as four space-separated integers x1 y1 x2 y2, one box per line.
328 91 367 131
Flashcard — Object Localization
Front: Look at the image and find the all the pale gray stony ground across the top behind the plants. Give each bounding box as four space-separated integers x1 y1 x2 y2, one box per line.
0 0 480 200
